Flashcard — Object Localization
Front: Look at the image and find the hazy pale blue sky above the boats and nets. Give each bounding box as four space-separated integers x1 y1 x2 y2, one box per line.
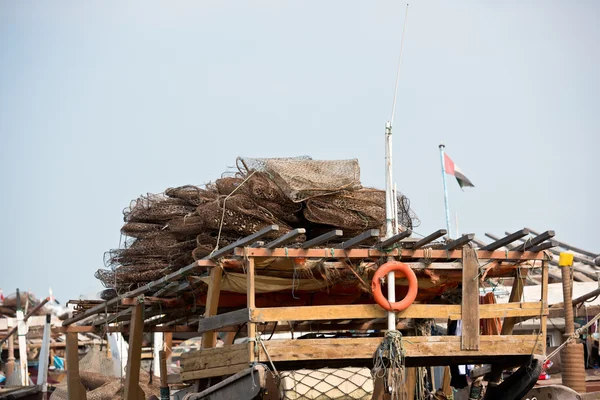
0 0 600 302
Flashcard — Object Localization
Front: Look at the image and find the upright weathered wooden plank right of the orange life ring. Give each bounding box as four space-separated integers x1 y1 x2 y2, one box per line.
460 247 479 350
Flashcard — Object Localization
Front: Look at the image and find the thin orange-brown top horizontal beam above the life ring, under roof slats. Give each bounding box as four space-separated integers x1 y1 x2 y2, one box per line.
234 248 545 262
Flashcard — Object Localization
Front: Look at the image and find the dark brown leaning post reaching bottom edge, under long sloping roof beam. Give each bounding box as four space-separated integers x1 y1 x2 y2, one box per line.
125 303 145 400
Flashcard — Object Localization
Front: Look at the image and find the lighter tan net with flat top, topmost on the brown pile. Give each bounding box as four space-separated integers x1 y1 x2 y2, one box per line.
238 157 362 203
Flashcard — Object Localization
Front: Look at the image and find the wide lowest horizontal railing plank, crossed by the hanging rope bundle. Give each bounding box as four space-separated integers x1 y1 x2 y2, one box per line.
258 335 542 362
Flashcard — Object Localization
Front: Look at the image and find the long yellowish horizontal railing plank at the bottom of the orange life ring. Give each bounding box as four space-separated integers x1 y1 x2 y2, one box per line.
250 302 548 323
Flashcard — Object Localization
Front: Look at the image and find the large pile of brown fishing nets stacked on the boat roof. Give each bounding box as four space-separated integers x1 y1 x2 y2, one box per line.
96 157 418 299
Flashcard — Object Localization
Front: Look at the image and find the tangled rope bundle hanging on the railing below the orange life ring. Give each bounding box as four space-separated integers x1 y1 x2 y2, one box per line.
371 330 407 400
